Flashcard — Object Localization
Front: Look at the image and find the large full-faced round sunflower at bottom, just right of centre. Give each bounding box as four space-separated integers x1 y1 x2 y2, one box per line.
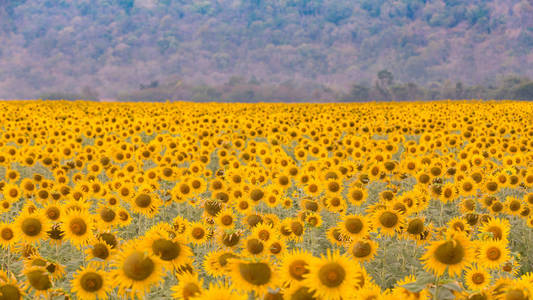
302 251 356 300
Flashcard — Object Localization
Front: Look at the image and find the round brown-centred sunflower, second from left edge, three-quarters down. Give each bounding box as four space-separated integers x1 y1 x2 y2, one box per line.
14 212 50 243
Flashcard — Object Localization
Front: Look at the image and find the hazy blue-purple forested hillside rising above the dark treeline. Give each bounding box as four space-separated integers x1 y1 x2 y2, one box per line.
0 0 533 98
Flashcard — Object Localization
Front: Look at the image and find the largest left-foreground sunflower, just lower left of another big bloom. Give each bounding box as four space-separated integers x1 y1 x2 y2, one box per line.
111 240 163 298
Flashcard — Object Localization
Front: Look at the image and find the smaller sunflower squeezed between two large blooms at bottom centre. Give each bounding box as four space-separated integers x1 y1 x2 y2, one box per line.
279 249 315 286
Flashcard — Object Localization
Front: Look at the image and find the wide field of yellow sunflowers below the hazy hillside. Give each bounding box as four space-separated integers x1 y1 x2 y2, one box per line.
0 101 533 300
